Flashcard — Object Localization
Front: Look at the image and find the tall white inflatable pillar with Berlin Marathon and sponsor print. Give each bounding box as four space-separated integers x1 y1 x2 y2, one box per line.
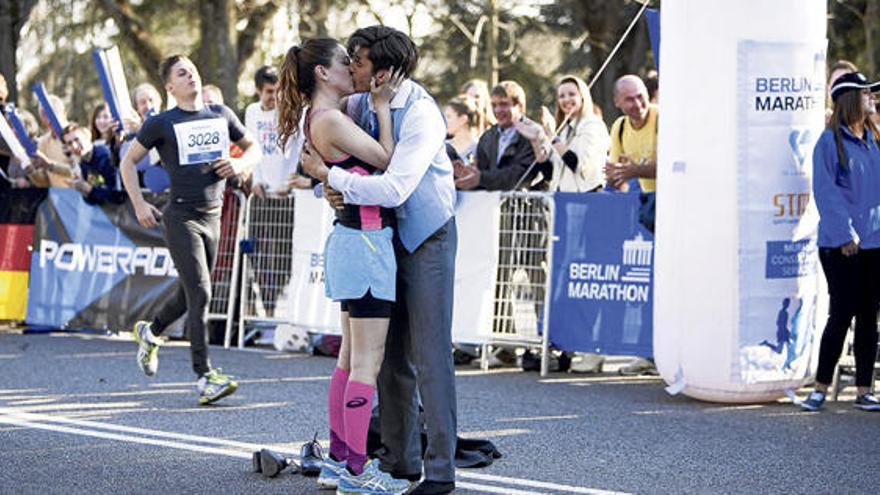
654 0 827 402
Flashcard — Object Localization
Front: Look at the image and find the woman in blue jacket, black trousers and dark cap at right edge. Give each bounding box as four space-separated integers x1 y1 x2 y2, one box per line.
801 72 880 411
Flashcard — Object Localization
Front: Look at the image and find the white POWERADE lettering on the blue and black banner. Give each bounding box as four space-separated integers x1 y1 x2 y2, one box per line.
39 239 177 277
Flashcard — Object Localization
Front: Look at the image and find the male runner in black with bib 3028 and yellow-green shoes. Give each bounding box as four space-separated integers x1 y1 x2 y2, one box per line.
120 55 260 404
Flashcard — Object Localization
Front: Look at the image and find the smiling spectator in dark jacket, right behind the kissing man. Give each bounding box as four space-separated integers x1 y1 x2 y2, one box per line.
455 81 553 191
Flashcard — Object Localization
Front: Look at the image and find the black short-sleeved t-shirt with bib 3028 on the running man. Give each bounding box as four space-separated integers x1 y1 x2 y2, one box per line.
137 105 246 204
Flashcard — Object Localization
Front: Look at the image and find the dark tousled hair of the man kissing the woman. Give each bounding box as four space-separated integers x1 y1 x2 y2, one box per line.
346 26 419 77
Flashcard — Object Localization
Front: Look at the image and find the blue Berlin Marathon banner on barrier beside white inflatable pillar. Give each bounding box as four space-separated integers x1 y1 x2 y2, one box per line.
550 192 662 357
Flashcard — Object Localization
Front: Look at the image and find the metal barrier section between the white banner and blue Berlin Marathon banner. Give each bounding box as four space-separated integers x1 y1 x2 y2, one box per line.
481 191 554 375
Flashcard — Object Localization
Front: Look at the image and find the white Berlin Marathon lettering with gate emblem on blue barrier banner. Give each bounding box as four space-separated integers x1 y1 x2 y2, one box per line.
568 233 654 303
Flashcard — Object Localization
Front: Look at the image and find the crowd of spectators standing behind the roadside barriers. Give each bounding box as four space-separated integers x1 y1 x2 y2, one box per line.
0 47 877 380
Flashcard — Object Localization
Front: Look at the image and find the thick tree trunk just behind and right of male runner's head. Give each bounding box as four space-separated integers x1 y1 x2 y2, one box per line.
193 0 239 111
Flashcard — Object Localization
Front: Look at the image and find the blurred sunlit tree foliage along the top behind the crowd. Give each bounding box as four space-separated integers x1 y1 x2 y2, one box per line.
12 0 880 130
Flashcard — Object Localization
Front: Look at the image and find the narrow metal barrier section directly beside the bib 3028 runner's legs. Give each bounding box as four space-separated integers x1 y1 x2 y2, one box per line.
208 189 245 348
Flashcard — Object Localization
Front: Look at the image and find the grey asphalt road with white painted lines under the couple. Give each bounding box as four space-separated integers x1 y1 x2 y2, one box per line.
0 332 880 494
